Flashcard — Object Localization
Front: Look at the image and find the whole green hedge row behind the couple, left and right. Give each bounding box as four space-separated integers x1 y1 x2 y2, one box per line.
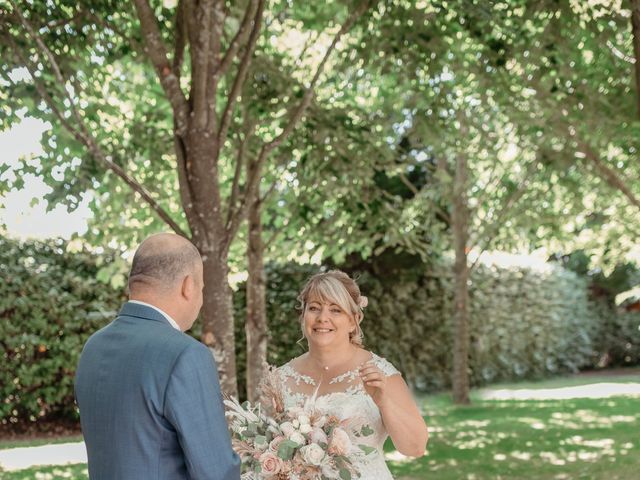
0 237 640 426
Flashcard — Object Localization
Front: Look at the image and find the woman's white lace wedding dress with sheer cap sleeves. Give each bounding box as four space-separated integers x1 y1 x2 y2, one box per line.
277 354 400 480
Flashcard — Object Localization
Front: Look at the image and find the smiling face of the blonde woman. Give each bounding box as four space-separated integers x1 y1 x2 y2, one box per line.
304 298 355 346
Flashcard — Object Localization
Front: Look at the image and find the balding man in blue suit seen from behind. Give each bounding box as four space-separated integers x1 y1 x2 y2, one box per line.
75 234 240 480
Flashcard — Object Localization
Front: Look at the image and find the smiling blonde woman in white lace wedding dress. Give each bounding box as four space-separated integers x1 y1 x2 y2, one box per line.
276 270 429 480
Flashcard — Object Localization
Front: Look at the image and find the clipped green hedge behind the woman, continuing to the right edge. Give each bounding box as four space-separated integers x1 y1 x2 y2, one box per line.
235 253 640 390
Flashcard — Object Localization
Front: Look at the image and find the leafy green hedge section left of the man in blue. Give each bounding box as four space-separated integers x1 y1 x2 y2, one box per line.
0 237 124 426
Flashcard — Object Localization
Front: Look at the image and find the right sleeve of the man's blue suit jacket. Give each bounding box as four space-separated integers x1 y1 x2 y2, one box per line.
164 343 240 480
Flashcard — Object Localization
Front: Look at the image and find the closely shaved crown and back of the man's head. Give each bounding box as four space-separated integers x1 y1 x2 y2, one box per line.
129 233 202 295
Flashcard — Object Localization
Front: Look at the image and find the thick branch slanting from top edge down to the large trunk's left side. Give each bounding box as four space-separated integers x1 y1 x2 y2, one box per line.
131 0 189 136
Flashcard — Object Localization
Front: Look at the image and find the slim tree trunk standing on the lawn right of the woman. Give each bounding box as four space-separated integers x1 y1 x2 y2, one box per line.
452 153 469 405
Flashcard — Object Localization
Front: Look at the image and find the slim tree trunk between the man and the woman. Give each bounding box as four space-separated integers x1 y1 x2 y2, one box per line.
245 194 268 402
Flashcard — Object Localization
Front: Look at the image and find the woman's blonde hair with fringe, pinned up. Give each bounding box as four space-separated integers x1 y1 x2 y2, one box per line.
298 270 367 346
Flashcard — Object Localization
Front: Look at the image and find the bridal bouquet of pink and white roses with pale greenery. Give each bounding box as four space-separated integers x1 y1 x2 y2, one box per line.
224 369 375 480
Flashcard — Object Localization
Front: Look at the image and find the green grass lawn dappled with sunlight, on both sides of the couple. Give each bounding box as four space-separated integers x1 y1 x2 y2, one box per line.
0 375 640 480
